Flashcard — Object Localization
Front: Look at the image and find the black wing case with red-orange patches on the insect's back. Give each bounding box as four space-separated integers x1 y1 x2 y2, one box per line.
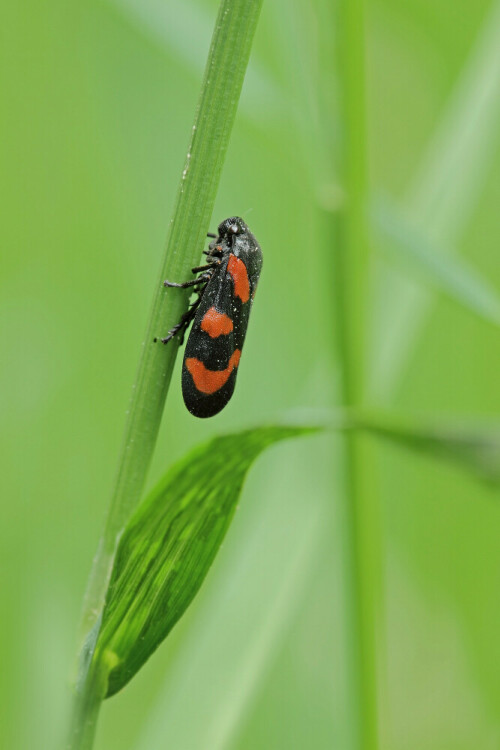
182 243 262 417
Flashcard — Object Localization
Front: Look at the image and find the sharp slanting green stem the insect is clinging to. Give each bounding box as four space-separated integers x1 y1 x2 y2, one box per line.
69 0 262 748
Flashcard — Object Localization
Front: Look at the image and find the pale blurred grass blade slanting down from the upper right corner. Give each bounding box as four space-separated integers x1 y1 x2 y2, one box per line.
370 0 500 400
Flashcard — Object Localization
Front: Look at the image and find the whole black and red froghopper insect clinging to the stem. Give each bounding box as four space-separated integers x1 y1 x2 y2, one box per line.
155 216 262 417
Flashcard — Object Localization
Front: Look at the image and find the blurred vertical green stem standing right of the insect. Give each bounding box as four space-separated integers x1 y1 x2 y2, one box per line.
324 0 378 750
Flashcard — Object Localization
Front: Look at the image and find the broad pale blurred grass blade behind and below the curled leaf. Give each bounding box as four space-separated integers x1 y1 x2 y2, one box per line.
135 439 328 750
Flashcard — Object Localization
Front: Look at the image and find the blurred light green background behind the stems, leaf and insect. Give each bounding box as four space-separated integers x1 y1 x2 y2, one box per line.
0 0 500 750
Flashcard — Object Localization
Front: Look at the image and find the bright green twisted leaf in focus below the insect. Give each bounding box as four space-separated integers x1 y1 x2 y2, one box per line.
93 427 316 697
